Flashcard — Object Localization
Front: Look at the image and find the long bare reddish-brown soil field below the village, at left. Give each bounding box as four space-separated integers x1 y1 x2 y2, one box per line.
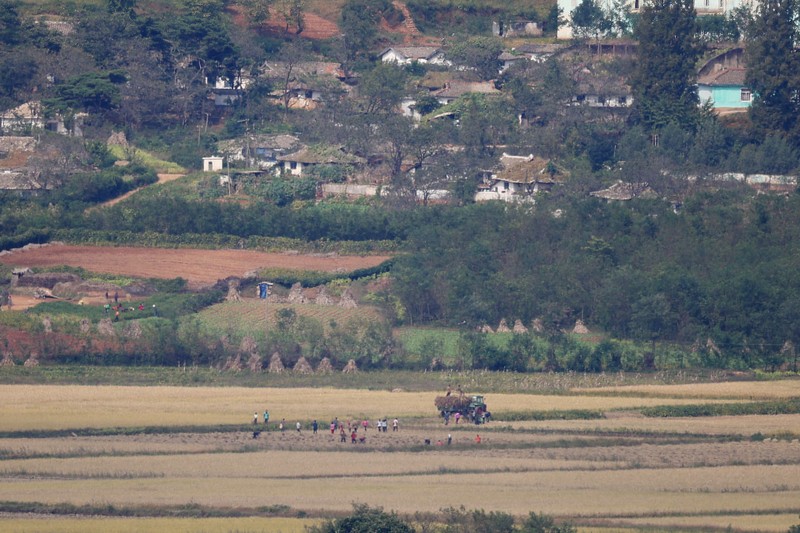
0 245 389 283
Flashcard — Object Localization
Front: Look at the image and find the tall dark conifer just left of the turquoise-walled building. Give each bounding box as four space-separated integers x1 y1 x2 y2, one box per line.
631 0 702 128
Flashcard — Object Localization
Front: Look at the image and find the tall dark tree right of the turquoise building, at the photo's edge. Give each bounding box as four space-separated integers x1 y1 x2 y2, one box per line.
746 0 800 146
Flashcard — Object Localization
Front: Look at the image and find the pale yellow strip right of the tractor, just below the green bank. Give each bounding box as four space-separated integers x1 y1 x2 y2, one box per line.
509 414 800 436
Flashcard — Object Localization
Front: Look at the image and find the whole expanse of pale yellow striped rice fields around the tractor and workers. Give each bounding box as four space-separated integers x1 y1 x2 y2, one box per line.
0 380 800 532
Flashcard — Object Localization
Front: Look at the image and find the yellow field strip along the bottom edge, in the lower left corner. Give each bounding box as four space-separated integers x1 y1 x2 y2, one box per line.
0 517 319 533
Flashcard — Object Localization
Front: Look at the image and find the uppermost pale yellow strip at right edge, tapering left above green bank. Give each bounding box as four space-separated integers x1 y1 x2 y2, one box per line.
574 379 800 400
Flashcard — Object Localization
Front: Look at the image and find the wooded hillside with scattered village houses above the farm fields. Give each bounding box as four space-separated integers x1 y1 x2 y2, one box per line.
0 0 800 367
